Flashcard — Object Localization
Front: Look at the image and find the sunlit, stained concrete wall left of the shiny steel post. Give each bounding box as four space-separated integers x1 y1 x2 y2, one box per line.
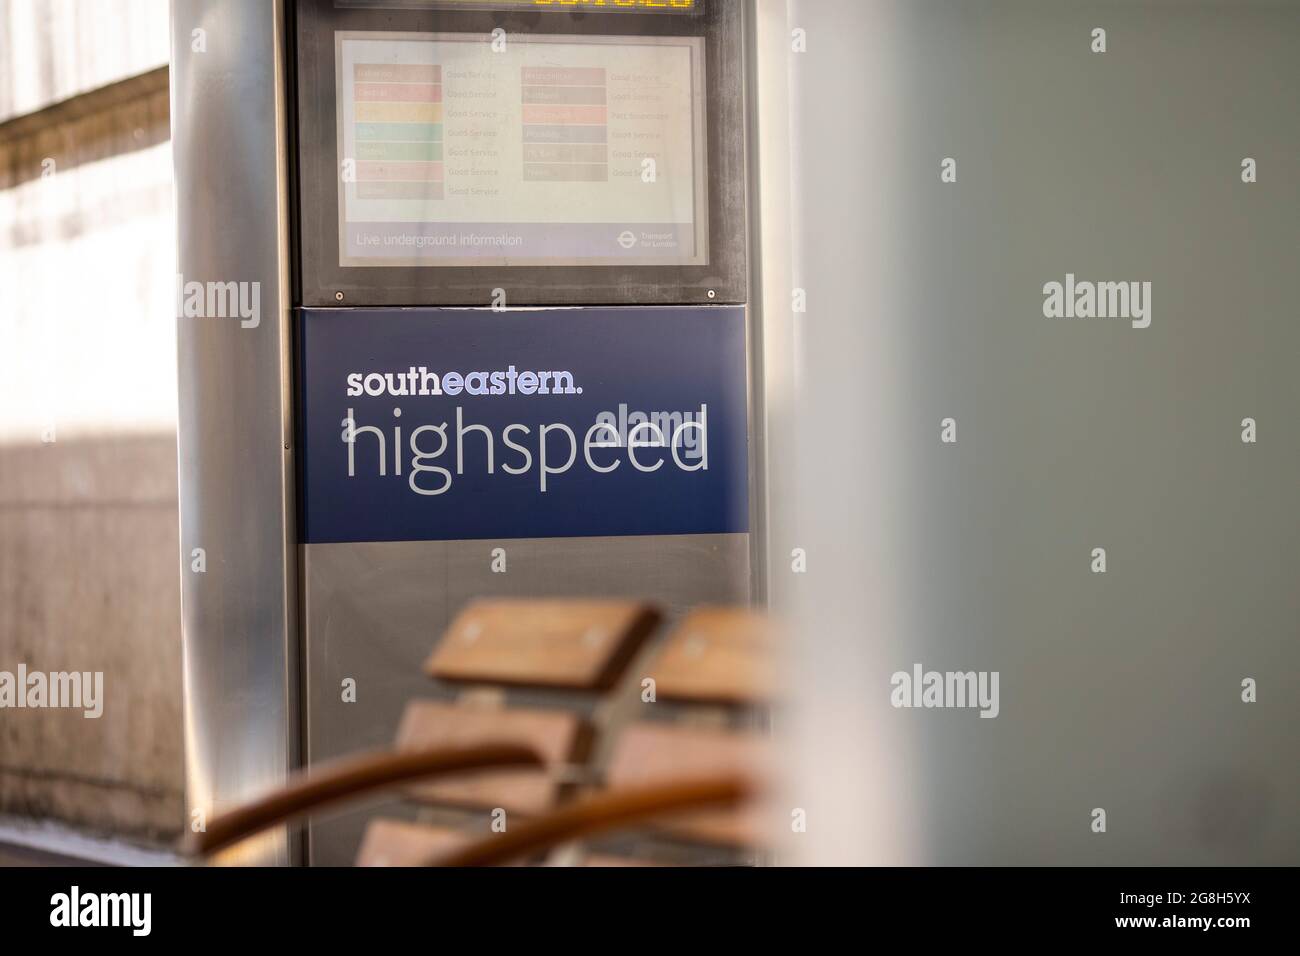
0 0 183 838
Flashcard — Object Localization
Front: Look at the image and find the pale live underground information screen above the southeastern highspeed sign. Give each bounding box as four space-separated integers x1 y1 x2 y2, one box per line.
334 31 709 267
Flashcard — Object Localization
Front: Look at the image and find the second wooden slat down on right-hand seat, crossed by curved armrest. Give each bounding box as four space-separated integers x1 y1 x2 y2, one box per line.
606 723 771 847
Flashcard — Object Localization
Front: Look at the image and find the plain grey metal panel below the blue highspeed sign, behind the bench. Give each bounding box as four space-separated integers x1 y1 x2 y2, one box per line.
303 535 750 865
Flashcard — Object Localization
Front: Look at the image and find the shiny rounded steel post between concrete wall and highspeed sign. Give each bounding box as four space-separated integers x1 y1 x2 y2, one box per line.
172 0 299 864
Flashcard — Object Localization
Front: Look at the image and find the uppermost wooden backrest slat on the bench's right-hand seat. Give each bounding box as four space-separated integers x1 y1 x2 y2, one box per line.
650 607 776 704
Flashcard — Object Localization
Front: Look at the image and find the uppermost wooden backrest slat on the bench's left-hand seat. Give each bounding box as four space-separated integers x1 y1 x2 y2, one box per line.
425 600 659 691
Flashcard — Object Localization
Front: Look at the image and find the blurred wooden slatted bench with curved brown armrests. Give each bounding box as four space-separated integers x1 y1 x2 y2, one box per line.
186 600 775 866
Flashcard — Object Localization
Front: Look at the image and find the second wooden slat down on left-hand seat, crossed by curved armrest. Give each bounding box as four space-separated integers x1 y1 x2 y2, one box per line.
397 701 589 814
